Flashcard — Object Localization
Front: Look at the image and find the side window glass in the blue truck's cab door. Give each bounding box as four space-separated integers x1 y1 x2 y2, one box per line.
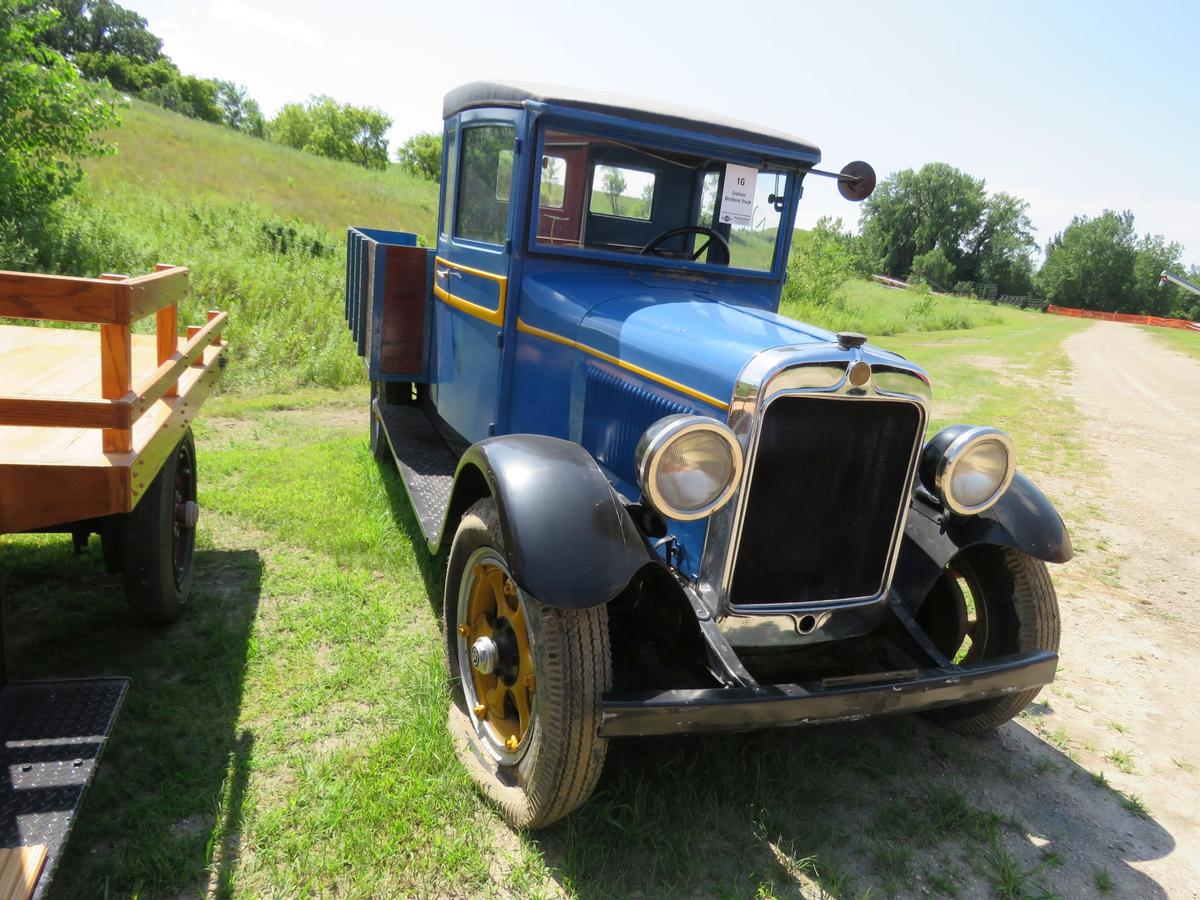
455 125 516 244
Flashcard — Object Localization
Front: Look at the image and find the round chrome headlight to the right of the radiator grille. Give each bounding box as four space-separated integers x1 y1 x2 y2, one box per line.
920 425 1016 516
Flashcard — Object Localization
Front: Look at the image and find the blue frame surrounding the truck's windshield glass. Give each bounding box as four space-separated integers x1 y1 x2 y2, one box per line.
524 110 812 281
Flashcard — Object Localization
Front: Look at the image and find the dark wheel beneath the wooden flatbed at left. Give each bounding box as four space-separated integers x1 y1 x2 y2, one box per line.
120 428 198 625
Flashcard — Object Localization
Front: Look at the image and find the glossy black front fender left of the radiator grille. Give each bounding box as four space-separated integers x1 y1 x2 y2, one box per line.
431 434 653 610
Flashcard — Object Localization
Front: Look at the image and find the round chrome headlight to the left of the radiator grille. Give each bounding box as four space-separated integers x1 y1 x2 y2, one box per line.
635 415 742 521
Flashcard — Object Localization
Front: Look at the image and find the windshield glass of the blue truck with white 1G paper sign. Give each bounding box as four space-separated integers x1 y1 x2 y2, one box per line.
536 130 791 272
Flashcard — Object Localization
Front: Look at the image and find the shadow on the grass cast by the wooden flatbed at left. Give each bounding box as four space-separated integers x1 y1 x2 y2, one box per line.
0 536 263 896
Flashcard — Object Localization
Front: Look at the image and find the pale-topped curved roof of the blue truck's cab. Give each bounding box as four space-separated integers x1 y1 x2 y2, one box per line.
442 82 821 163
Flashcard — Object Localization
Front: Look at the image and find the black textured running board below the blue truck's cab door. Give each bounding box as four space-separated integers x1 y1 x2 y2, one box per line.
372 402 458 546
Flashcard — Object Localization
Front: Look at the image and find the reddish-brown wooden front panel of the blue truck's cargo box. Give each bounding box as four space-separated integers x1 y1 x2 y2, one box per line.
379 247 428 374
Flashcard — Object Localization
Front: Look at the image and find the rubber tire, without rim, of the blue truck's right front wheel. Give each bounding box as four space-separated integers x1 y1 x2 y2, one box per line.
926 547 1061 737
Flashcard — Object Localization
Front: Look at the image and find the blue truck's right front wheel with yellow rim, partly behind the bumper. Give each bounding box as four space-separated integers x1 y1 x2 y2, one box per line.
923 547 1061 736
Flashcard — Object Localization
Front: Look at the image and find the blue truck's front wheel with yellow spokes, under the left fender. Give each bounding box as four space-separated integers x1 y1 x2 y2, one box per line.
444 498 612 829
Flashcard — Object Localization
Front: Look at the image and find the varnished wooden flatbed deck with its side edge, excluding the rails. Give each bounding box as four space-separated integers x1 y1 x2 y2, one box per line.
0 325 226 534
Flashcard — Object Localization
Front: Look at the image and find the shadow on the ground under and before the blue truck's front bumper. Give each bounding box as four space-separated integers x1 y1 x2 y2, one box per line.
526 716 1175 898
